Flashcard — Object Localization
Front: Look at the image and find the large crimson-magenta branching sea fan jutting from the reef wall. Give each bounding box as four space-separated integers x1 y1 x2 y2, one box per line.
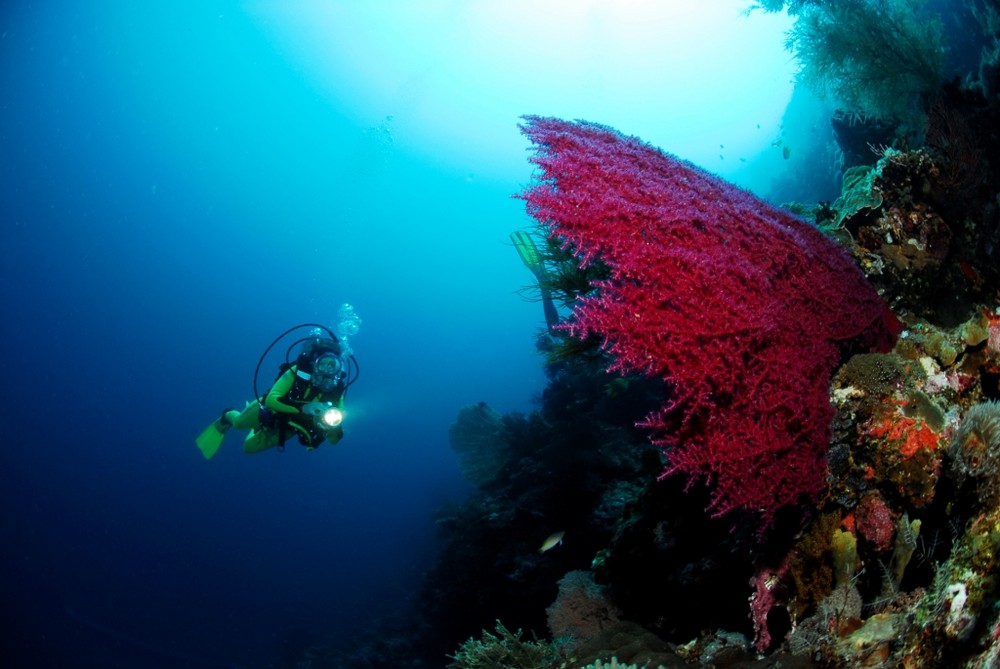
520 116 895 528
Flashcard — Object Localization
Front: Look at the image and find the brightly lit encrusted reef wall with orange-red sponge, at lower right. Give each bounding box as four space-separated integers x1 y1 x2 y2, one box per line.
758 310 1000 667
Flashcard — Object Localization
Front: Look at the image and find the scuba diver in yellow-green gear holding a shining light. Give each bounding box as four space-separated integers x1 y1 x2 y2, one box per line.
196 323 358 460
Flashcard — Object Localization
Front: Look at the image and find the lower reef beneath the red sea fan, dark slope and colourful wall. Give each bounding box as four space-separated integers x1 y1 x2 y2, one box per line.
276 188 1000 669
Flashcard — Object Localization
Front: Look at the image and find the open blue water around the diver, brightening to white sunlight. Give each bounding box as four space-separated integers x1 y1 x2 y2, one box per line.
0 0 795 669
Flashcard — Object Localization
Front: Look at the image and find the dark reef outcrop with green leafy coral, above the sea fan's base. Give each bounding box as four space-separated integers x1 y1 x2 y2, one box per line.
834 148 1000 324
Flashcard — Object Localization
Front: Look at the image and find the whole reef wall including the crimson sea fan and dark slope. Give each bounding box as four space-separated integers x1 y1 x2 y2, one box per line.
283 6 1000 669
